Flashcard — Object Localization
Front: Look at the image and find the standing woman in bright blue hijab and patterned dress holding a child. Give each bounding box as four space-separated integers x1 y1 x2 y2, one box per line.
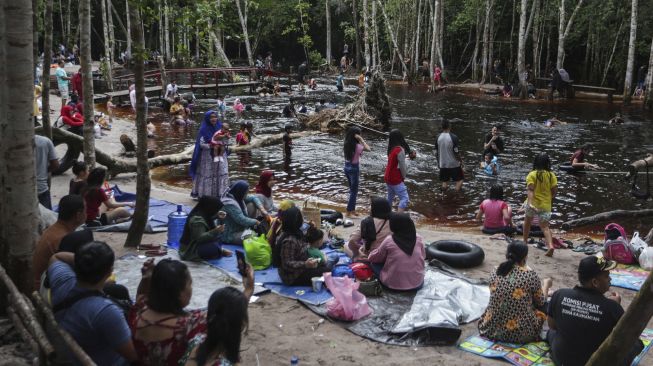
189 110 229 198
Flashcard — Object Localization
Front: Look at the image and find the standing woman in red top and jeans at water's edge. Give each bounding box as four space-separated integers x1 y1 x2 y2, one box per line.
383 129 415 212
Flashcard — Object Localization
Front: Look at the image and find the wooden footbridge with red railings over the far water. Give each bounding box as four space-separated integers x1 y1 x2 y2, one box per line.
94 67 291 103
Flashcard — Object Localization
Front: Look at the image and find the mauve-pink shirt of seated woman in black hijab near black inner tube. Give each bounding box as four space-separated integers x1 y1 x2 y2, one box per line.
368 235 426 290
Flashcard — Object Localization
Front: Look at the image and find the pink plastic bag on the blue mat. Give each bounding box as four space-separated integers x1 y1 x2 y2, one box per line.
324 273 372 321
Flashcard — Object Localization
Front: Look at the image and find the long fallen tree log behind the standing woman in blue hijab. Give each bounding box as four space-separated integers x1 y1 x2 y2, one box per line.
35 127 319 177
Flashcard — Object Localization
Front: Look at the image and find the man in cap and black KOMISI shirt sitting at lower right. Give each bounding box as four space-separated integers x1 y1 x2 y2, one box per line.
547 256 643 366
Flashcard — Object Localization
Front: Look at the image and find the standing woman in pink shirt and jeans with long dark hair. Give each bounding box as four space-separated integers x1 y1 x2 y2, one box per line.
344 126 370 216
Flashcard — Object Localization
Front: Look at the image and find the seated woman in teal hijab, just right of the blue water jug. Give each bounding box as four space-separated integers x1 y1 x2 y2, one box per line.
222 180 262 245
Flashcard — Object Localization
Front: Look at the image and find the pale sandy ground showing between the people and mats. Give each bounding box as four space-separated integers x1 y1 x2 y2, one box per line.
42 95 653 365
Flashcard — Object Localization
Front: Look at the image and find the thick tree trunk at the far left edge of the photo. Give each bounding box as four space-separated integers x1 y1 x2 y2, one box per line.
0 0 39 293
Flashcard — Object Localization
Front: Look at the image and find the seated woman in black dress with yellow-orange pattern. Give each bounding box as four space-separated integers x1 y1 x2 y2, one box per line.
478 242 552 343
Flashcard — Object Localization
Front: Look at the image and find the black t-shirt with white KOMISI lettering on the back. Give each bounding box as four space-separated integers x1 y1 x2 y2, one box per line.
548 286 624 365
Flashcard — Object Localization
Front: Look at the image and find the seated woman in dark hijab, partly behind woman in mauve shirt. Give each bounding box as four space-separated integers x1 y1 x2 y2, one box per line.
343 197 392 258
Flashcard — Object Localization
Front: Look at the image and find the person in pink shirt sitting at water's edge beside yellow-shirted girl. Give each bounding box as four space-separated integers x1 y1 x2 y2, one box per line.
476 184 515 234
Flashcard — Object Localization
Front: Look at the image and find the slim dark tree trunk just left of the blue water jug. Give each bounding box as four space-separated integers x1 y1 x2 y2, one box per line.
125 0 151 247
